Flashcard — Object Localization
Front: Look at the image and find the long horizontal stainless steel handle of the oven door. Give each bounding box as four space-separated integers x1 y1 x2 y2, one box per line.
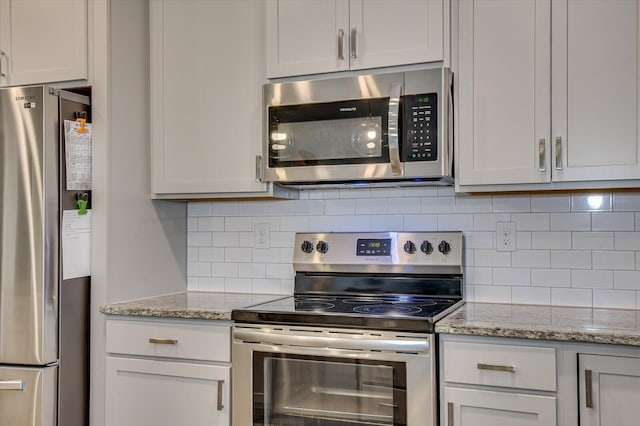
233 329 429 352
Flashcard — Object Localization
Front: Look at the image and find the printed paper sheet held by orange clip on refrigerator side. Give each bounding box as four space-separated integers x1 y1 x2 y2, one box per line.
64 120 93 191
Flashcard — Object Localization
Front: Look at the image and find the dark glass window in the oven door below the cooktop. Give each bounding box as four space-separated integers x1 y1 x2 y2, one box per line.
253 352 406 426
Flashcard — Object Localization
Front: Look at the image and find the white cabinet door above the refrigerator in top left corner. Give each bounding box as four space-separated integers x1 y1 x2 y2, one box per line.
0 0 87 86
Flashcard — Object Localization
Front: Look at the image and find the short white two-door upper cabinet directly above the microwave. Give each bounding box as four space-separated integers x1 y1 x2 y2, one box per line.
267 0 448 78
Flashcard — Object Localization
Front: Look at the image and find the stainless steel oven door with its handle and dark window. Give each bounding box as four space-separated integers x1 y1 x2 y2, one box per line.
233 325 436 426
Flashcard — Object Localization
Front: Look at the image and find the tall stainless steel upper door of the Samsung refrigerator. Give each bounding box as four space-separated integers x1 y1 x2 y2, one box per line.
0 86 58 364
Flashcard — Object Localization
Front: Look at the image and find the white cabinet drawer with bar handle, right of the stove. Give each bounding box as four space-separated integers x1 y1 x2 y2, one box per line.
444 342 556 391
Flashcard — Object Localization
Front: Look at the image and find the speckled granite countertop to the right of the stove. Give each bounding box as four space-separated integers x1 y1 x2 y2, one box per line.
435 303 640 346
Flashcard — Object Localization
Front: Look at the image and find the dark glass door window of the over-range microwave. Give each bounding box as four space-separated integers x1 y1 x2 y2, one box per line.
269 98 389 167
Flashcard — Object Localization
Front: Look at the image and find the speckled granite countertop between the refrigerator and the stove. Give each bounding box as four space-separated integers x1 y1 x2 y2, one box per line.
100 291 287 320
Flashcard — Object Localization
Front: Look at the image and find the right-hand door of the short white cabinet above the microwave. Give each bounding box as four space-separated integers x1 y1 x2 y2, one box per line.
349 0 444 69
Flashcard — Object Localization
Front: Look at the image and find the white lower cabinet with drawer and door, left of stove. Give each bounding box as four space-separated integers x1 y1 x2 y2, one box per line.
106 318 231 426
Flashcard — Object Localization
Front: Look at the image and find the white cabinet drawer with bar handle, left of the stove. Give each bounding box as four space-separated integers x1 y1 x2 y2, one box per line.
107 320 231 362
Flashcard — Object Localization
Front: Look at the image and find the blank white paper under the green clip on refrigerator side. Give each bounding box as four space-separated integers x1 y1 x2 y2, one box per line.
61 210 91 280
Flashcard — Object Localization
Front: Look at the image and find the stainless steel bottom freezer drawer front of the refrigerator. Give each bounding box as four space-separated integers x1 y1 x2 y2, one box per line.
0 366 58 426
